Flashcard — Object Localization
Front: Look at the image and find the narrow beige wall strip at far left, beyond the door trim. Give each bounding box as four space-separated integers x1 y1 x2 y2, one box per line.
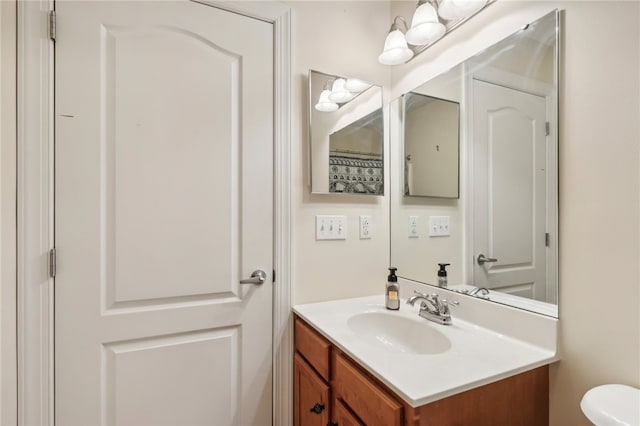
0 0 17 425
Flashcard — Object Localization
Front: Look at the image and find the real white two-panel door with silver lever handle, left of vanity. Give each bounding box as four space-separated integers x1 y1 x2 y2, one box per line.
55 1 273 425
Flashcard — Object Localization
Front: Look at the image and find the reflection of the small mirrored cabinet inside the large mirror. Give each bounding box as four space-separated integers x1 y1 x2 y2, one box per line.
403 92 460 198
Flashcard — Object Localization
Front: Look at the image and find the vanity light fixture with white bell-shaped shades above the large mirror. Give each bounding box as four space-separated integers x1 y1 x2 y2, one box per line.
378 0 495 65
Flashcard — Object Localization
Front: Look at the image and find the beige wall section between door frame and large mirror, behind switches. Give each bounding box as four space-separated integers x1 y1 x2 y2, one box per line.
286 1 389 304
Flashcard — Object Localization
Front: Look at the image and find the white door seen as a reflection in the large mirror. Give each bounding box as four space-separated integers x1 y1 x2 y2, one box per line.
473 79 547 300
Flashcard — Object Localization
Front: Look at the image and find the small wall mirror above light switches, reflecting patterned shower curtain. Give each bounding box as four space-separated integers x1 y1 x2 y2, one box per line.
309 70 384 195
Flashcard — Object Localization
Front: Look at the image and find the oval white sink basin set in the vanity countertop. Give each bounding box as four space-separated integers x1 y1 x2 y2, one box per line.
347 312 451 355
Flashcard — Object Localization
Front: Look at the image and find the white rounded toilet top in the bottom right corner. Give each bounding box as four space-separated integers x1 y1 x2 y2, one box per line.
580 384 640 426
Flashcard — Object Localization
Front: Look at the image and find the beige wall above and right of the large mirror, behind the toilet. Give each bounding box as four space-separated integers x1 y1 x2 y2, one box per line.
392 0 640 426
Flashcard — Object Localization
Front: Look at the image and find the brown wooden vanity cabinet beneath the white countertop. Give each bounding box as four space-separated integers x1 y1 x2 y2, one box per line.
294 316 549 426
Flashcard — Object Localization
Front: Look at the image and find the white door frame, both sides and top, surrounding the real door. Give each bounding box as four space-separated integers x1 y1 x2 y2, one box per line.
16 0 293 425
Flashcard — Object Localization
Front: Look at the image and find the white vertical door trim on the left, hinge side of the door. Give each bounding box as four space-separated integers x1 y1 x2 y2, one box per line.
16 0 54 425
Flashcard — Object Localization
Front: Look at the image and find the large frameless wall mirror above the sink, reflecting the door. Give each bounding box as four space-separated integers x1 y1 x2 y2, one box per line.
390 11 559 317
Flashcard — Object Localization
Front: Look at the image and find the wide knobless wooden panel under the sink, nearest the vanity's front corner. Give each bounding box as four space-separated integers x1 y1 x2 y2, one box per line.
332 354 402 426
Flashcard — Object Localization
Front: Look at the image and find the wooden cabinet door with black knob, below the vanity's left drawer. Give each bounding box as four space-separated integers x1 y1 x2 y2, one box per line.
293 354 329 426
